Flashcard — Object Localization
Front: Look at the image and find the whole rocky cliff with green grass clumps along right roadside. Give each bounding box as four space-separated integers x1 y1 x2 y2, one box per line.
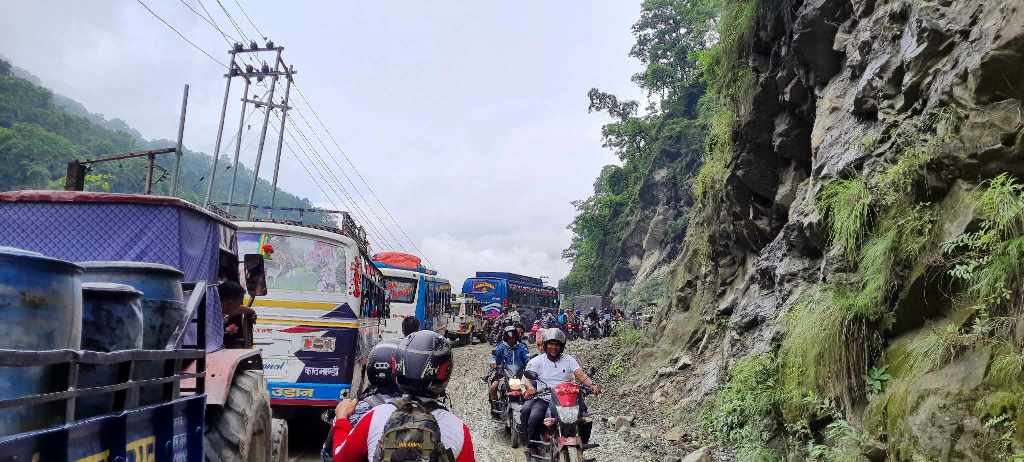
609 0 1024 461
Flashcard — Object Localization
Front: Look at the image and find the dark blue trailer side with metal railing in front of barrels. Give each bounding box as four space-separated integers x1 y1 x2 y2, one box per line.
0 282 208 462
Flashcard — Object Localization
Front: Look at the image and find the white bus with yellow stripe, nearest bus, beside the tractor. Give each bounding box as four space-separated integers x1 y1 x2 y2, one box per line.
236 221 387 409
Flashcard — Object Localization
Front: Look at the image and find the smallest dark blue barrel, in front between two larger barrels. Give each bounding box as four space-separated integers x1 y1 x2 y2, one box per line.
75 283 142 419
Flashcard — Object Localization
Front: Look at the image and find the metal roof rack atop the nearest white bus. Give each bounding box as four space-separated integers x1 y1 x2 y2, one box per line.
207 202 370 255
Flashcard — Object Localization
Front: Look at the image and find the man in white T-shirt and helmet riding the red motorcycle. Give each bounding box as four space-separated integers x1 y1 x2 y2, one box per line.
520 328 601 460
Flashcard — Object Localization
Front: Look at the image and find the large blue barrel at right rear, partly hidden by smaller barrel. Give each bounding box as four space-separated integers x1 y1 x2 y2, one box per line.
79 261 185 405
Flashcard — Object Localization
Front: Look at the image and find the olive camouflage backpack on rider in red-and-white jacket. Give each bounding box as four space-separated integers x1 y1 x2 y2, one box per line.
373 396 455 462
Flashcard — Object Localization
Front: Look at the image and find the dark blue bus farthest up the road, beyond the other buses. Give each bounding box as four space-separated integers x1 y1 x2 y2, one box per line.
462 271 558 330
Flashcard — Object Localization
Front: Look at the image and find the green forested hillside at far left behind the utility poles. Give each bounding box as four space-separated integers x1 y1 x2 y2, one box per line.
0 59 312 215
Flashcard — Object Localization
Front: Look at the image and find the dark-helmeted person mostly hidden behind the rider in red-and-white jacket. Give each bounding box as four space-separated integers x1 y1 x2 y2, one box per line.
321 339 401 462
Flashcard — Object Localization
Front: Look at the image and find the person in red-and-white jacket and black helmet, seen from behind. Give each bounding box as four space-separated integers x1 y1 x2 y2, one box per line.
333 331 476 462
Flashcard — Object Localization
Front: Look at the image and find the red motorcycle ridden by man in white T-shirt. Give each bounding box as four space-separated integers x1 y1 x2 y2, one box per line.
523 371 599 462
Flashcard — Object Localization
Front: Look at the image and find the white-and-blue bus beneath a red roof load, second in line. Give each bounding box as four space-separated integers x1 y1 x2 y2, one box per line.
375 262 452 339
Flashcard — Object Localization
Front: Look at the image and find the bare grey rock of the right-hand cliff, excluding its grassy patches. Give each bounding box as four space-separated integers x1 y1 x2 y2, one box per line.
611 0 1024 460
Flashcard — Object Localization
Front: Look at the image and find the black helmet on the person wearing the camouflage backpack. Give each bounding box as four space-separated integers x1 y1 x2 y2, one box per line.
397 331 452 397
